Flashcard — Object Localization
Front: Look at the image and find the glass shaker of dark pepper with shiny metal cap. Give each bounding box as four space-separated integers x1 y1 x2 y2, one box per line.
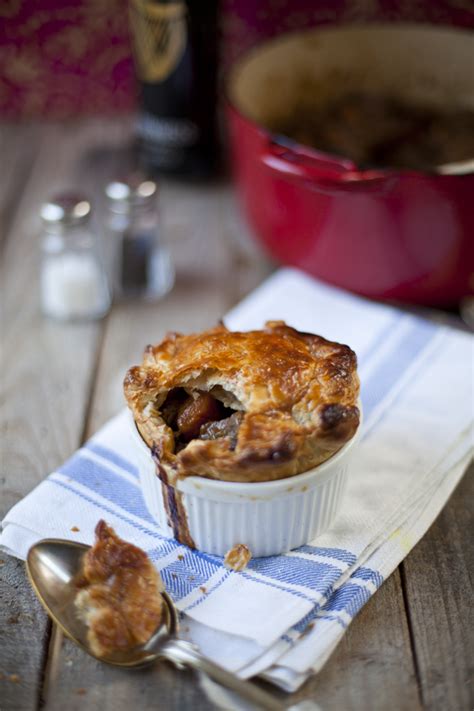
105 178 174 301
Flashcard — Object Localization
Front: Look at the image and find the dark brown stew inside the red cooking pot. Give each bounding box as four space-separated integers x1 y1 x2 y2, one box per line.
269 92 474 170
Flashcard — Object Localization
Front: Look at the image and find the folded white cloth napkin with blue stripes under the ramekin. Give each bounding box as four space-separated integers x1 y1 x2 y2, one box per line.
0 269 473 691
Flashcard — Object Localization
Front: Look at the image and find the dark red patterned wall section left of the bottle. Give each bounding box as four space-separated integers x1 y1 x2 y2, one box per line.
0 0 134 118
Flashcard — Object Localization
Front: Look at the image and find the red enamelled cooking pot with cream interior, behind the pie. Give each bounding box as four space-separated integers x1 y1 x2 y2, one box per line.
227 24 474 306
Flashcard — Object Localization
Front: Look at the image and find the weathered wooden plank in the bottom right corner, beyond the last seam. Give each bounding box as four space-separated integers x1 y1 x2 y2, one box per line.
403 464 474 711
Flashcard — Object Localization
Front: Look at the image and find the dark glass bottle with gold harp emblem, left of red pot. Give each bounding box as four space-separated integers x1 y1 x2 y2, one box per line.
130 0 218 177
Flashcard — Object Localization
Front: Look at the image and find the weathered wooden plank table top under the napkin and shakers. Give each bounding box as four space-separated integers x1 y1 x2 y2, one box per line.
0 119 474 711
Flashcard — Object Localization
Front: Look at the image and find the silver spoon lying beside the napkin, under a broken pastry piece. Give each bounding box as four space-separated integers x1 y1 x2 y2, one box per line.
26 539 286 711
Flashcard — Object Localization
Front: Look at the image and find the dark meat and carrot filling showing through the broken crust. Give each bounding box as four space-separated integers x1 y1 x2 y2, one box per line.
160 388 244 452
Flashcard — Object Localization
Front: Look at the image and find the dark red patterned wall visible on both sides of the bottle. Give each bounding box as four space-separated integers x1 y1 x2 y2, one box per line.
0 0 474 118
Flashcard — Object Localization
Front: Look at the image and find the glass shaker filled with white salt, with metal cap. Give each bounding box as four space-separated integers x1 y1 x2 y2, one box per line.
40 193 110 321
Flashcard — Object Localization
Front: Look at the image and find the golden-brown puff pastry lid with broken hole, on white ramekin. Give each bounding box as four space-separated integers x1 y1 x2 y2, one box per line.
124 321 360 485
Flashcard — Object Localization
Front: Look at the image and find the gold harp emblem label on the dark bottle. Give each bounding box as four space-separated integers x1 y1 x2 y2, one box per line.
130 0 187 83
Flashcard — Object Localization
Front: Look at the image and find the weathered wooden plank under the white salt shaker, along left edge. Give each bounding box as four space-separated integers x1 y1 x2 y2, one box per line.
0 122 130 711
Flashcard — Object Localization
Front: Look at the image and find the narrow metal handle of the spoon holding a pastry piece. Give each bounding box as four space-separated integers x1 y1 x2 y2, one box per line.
160 639 285 711
